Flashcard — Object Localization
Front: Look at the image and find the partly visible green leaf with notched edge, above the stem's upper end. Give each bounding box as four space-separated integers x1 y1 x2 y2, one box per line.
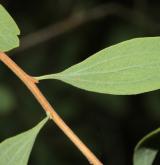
0 5 20 52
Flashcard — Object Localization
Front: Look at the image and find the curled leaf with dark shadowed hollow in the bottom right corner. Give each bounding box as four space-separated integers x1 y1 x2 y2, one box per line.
133 128 160 165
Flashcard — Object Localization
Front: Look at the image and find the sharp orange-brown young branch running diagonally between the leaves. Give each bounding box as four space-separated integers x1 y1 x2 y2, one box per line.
0 52 102 165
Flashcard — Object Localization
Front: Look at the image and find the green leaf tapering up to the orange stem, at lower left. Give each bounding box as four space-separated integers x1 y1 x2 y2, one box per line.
0 117 48 165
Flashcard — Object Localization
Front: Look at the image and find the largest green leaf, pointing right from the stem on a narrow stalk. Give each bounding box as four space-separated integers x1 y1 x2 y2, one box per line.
37 37 160 95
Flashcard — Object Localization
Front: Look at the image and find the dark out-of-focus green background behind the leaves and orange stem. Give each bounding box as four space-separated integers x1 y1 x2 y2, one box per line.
0 0 160 165
